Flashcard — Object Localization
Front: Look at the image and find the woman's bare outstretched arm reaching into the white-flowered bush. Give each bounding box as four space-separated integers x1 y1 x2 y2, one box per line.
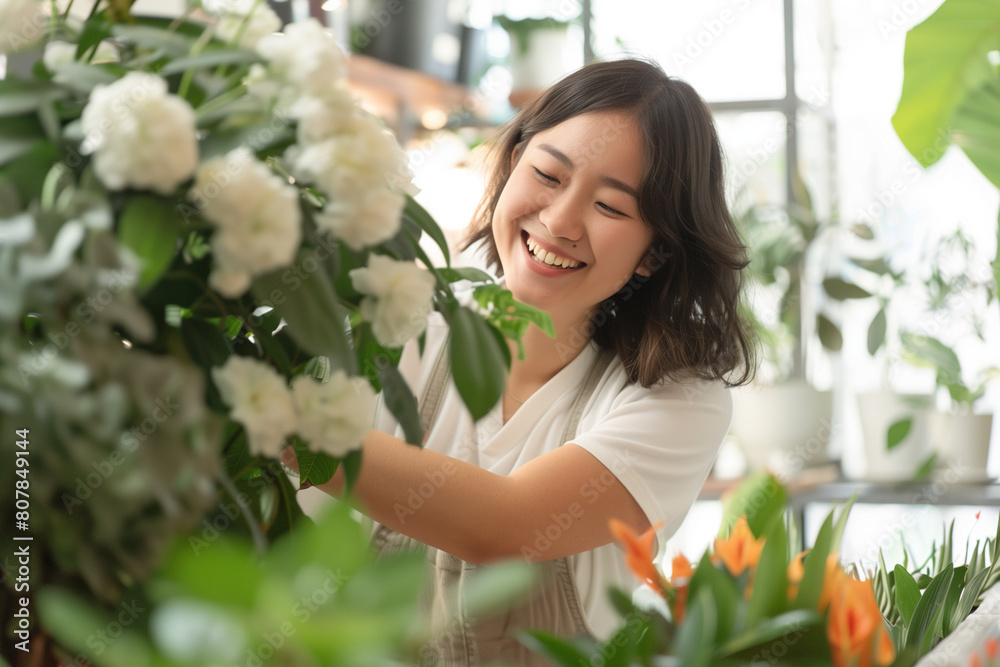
283 430 649 564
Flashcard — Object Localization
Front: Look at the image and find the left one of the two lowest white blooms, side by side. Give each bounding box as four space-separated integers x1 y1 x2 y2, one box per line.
212 355 296 457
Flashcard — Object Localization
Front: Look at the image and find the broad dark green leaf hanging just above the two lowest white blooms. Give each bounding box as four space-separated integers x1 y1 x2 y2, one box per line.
251 249 357 375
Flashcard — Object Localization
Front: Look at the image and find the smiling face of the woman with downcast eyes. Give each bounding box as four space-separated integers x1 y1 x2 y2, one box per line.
493 111 653 326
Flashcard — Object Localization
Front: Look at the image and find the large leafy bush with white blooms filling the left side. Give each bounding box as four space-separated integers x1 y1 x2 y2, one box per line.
0 0 546 664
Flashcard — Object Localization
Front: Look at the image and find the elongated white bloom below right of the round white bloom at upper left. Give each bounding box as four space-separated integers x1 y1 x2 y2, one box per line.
190 147 302 297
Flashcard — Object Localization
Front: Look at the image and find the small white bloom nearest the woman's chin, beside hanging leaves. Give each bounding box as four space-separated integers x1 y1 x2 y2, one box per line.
349 255 434 347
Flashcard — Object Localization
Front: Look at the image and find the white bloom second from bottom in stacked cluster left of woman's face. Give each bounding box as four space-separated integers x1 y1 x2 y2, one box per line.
286 115 413 199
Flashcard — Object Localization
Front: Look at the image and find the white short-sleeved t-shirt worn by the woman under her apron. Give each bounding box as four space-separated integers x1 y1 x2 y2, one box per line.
374 306 732 639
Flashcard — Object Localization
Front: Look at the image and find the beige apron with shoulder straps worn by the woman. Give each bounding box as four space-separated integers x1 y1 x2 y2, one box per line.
372 343 614 667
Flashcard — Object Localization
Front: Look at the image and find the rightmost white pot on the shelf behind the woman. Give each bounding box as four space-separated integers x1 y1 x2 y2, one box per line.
931 412 993 482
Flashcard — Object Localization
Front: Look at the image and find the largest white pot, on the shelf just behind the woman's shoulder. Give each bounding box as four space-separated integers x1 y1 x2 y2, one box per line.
731 380 835 477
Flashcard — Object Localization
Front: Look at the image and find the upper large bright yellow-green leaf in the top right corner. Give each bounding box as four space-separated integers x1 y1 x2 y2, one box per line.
892 0 1000 167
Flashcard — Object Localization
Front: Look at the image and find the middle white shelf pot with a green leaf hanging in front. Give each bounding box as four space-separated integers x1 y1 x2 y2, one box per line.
858 391 933 482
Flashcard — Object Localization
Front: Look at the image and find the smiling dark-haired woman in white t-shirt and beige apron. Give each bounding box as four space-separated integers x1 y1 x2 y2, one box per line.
286 56 754 665
